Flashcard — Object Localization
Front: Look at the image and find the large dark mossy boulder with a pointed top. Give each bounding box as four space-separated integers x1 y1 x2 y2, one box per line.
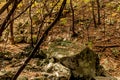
59 47 109 80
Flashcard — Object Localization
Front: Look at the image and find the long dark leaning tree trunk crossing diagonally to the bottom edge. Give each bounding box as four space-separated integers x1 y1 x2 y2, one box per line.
12 0 66 80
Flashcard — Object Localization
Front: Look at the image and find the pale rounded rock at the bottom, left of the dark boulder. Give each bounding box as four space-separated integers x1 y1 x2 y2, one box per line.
42 63 71 80
